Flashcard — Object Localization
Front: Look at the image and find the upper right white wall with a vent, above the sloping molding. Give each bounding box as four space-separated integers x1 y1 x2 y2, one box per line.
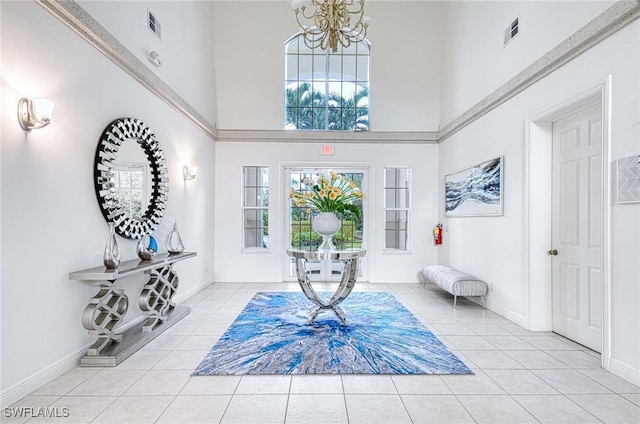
440 1 614 125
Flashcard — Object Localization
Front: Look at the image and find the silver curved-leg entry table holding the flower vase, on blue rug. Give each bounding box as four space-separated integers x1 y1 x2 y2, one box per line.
287 249 367 325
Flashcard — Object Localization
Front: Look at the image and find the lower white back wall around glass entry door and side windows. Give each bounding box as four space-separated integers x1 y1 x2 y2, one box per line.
215 141 438 283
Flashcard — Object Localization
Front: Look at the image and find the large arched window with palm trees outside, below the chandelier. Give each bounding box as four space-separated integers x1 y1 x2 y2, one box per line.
285 33 371 131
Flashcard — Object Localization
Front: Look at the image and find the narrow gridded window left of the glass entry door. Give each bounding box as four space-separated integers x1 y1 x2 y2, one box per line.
242 166 269 249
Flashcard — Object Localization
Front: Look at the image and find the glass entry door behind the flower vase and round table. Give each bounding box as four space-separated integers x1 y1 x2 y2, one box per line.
285 167 366 281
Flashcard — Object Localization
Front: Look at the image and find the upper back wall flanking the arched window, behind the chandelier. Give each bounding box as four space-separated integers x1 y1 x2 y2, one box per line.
213 1 441 131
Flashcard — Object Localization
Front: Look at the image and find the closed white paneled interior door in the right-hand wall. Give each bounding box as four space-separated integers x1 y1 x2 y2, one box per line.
549 104 603 352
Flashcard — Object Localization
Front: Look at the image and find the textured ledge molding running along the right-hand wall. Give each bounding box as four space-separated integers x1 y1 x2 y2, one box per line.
438 0 640 143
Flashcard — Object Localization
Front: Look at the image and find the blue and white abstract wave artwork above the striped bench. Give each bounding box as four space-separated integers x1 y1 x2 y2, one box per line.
444 157 504 217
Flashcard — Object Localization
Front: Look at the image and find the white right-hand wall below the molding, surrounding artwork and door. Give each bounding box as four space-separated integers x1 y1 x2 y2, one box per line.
438 14 640 382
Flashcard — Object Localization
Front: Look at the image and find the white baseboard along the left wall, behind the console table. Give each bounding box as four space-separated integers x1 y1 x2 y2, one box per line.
0 315 146 408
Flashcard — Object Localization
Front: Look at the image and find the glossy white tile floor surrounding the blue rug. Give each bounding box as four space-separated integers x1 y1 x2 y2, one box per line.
2 283 640 424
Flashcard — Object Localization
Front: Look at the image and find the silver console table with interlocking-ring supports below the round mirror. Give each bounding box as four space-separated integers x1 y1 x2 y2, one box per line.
69 252 197 366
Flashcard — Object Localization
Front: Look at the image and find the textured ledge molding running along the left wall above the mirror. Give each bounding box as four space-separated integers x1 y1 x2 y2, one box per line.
36 0 216 140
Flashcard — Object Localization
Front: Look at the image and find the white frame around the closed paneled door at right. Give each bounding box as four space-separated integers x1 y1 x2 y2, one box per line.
524 75 612 370
